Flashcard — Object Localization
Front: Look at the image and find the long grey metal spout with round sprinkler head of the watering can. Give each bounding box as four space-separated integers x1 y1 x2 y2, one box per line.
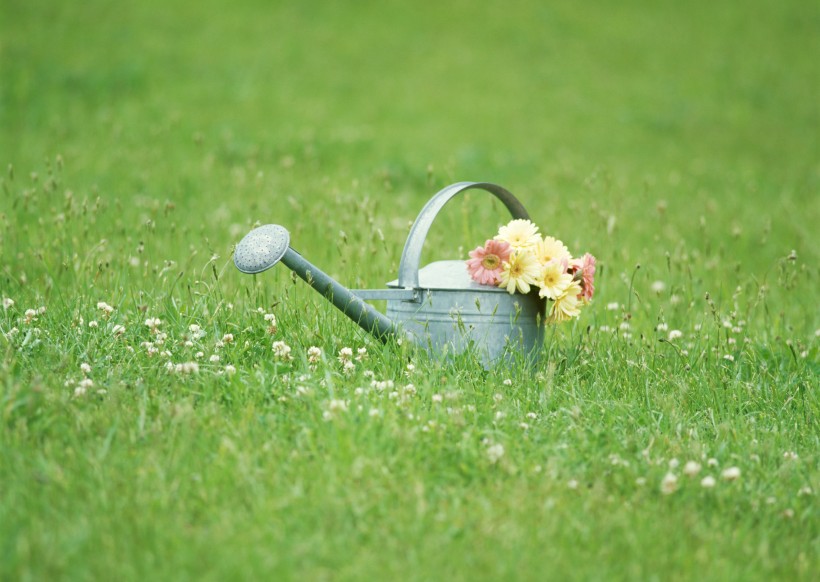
234 224 399 341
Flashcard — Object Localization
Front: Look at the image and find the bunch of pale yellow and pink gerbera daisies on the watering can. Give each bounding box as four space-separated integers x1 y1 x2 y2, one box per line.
466 218 595 323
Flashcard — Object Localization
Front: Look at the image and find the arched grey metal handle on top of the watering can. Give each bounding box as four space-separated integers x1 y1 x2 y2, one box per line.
399 182 530 289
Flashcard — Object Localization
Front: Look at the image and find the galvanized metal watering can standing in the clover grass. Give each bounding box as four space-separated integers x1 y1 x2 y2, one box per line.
234 182 546 367
